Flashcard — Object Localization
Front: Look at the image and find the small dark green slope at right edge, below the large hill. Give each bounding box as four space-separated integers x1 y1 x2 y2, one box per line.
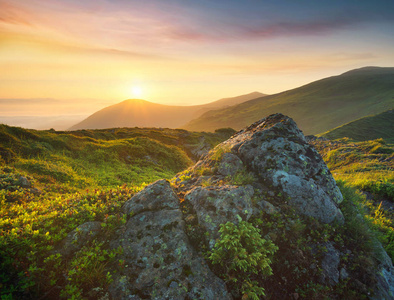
319 109 394 143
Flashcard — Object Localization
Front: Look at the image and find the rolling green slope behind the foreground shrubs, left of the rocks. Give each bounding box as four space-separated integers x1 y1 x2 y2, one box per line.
0 125 234 188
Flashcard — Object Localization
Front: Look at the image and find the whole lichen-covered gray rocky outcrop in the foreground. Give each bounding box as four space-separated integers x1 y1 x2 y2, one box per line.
84 114 394 299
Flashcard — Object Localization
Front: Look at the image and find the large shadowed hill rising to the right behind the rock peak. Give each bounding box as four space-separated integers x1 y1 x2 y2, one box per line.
183 67 394 134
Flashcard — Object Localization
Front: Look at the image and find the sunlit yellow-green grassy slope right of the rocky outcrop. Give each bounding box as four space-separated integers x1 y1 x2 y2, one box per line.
310 138 394 259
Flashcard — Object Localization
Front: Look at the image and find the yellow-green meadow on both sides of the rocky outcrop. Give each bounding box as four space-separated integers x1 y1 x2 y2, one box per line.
0 125 394 299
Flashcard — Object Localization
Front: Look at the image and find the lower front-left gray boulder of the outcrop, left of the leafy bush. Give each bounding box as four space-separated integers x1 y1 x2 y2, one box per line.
109 180 231 299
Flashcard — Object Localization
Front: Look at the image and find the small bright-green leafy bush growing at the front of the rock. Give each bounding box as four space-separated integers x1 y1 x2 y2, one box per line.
209 221 278 300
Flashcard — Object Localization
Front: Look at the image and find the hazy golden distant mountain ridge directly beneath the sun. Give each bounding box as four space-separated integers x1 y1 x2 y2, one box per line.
69 92 265 130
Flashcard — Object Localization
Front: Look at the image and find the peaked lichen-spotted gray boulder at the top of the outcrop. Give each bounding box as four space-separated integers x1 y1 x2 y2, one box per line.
221 114 344 223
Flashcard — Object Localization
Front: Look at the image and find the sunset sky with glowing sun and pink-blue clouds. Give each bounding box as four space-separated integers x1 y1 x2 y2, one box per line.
0 0 394 117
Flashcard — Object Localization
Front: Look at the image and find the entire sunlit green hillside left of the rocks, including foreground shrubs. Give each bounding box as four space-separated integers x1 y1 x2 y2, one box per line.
0 125 233 299
